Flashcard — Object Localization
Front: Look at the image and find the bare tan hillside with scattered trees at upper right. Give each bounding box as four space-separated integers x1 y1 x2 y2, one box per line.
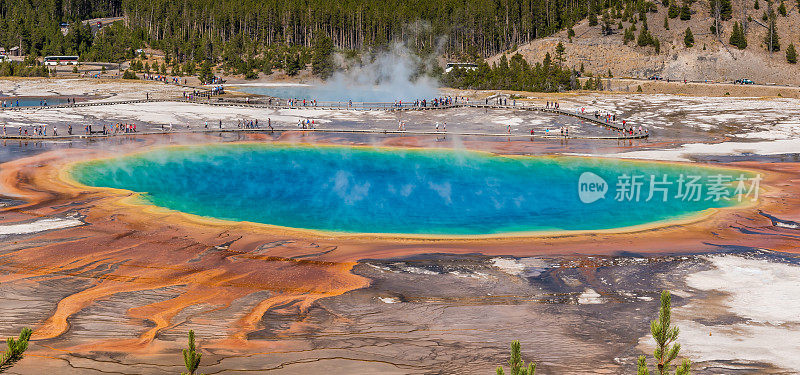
488 0 800 85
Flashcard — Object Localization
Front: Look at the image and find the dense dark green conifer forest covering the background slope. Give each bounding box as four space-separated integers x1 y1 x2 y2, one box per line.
0 0 652 63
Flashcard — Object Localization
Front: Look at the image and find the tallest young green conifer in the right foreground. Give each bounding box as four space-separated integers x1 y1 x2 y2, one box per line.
637 290 691 375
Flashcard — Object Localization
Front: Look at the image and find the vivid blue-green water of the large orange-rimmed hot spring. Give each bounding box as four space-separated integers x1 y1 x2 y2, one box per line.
72 144 752 235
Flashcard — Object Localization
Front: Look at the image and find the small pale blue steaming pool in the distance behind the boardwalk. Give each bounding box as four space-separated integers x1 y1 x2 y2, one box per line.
234 83 437 103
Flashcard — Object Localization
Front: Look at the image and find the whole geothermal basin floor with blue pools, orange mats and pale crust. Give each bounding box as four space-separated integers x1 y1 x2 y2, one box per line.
0 75 800 375
